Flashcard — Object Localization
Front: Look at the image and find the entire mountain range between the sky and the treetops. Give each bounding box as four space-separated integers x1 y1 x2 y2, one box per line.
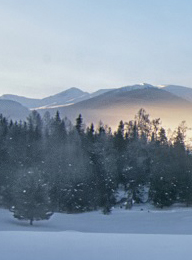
0 83 192 129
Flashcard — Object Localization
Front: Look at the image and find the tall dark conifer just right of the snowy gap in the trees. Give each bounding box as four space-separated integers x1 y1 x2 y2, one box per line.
149 128 178 208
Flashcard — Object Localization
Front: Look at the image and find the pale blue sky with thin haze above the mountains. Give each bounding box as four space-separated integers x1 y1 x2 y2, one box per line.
0 0 192 98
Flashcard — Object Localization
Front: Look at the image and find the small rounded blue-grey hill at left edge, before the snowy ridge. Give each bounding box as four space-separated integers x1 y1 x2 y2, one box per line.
0 99 30 120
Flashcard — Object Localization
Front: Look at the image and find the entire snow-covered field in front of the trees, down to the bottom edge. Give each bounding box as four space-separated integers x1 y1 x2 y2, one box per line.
0 207 192 260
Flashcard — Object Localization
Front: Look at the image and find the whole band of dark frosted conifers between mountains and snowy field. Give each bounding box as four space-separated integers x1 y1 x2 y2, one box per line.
0 109 192 217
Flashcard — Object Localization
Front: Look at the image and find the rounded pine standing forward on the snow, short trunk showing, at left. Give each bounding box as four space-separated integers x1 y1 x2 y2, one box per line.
10 169 53 225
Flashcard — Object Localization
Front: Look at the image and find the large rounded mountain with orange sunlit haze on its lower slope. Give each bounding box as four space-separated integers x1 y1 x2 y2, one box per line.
39 85 192 129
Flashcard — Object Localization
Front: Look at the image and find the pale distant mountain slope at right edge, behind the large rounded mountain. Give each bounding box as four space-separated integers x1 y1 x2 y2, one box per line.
163 85 192 102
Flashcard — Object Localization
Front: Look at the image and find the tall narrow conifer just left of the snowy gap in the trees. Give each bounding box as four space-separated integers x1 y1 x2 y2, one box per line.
91 128 117 214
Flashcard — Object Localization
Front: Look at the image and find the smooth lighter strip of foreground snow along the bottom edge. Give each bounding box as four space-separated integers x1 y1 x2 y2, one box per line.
0 231 192 260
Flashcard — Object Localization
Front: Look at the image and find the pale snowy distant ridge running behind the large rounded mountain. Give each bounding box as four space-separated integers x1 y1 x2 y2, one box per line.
0 83 192 109
